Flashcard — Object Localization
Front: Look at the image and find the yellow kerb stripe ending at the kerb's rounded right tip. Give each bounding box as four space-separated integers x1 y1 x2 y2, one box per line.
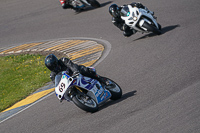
68 45 104 60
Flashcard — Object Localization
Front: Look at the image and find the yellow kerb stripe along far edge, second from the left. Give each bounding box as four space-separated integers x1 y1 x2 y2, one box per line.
45 40 87 51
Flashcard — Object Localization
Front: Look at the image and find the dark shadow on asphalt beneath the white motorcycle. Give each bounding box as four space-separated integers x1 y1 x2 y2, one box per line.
133 25 180 41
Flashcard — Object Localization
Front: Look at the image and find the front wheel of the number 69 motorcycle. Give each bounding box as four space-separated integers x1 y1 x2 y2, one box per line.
72 94 98 113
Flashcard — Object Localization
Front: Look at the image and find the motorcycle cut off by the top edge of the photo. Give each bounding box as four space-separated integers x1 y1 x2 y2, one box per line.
69 0 100 9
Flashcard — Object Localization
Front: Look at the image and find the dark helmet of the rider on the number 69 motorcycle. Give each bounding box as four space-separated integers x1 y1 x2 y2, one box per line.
45 54 58 72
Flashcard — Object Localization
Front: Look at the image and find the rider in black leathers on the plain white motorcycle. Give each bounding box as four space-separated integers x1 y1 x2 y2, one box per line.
109 2 154 37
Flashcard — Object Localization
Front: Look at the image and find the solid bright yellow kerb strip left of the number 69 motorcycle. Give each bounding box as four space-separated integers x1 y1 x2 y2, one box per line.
3 88 55 112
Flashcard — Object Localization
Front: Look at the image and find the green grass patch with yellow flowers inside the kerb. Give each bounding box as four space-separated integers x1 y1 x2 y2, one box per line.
0 54 51 112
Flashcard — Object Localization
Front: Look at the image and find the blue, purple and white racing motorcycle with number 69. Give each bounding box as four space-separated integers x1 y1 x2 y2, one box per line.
55 68 122 112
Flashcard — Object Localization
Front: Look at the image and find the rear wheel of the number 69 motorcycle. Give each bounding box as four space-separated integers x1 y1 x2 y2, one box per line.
106 78 122 100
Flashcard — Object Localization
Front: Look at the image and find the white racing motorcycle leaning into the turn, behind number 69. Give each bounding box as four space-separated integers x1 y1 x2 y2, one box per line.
121 5 161 35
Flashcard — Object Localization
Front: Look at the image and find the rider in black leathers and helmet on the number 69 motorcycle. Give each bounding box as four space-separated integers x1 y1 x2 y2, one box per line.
45 54 109 85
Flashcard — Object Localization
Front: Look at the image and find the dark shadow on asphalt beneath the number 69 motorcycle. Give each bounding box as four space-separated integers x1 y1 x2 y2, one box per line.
99 90 137 111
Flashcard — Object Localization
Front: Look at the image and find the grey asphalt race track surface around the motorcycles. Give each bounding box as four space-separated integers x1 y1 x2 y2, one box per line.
0 0 200 133
